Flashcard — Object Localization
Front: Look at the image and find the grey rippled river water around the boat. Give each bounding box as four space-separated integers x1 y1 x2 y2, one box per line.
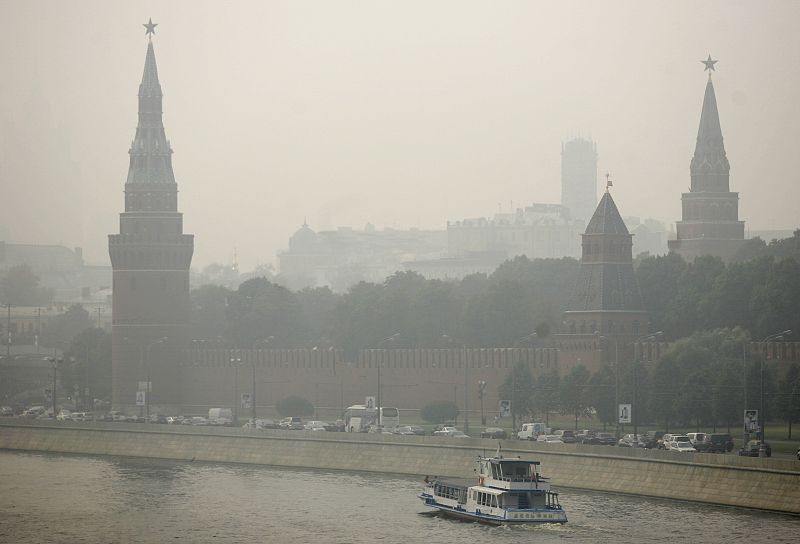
0 452 800 544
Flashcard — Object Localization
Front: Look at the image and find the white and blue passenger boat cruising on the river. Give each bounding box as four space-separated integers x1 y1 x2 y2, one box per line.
418 455 567 525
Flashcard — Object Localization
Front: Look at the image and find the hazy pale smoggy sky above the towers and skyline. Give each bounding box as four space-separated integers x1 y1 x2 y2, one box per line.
0 0 800 269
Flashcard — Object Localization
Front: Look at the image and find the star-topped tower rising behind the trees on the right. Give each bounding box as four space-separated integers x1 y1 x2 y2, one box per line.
669 61 744 261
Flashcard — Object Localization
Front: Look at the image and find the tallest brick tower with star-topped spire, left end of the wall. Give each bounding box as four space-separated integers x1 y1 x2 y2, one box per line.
108 21 194 415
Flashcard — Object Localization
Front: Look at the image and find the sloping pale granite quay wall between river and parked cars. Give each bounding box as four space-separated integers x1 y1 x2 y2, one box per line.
0 422 800 514
